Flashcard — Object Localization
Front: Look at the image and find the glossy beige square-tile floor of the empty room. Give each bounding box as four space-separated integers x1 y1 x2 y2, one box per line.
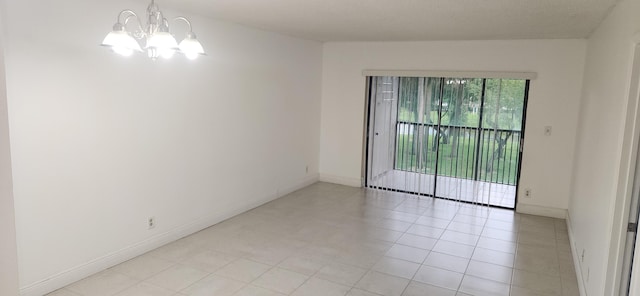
49 183 579 296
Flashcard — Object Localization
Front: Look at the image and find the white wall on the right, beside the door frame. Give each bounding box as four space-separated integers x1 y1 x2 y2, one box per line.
569 0 640 295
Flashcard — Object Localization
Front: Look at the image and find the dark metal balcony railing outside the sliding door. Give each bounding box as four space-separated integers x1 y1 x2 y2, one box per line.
394 121 521 185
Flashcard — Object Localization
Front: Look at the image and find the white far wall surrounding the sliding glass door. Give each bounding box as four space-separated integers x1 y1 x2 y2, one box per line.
320 40 586 216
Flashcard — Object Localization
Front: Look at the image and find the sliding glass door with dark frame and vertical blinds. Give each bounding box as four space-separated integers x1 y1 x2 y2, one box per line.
365 76 529 208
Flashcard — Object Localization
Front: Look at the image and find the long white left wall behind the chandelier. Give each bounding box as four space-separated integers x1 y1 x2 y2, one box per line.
2 0 322 295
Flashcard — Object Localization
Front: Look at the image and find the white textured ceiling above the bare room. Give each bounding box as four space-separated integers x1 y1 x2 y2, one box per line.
156 0 618 41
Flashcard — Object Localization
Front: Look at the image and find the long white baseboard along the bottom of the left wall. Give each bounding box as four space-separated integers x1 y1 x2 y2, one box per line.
20 178 318 296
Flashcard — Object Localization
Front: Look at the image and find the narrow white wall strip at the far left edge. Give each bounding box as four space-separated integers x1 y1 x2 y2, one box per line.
0 1 18 296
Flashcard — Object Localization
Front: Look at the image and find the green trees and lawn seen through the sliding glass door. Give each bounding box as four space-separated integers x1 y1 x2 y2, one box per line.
396 77 526 185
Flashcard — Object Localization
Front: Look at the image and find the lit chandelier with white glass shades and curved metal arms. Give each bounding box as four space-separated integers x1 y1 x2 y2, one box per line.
101 0 205 60
